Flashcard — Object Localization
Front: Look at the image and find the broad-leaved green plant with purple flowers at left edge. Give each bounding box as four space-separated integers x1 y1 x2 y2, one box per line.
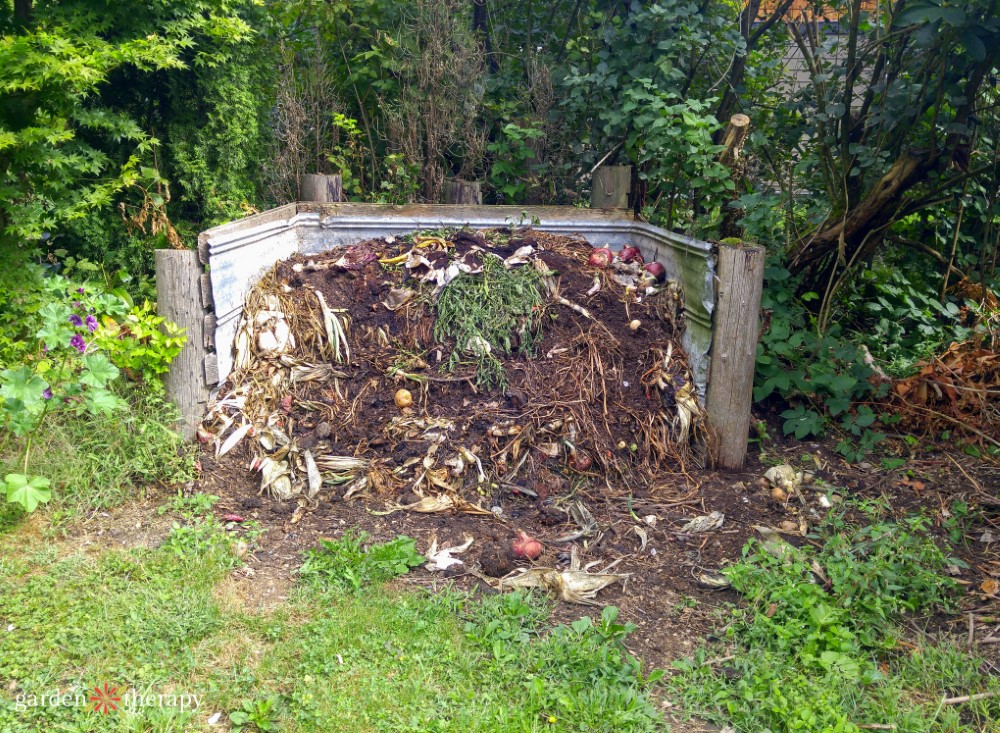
0 264 184 511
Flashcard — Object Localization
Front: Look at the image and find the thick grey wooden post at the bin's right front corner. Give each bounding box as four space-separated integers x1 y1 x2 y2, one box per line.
707 244 764 471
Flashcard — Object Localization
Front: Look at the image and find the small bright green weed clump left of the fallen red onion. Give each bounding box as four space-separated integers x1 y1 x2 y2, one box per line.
299 531 426 593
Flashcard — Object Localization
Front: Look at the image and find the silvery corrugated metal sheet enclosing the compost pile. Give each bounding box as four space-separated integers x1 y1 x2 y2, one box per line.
199 204 715 395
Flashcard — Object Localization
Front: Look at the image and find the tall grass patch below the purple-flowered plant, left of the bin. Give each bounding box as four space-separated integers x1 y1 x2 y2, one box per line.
0 388 194 516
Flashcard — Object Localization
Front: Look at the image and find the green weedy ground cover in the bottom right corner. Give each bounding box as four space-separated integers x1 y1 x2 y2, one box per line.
671 506 1000 733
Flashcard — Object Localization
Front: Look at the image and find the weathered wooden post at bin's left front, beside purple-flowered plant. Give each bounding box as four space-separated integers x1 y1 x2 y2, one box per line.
156 249 208 440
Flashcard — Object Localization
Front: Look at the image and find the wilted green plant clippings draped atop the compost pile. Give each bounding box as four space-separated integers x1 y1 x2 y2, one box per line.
434 255 543 391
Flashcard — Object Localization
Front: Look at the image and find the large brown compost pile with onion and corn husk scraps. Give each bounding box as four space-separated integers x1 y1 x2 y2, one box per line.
199 229 705 513
